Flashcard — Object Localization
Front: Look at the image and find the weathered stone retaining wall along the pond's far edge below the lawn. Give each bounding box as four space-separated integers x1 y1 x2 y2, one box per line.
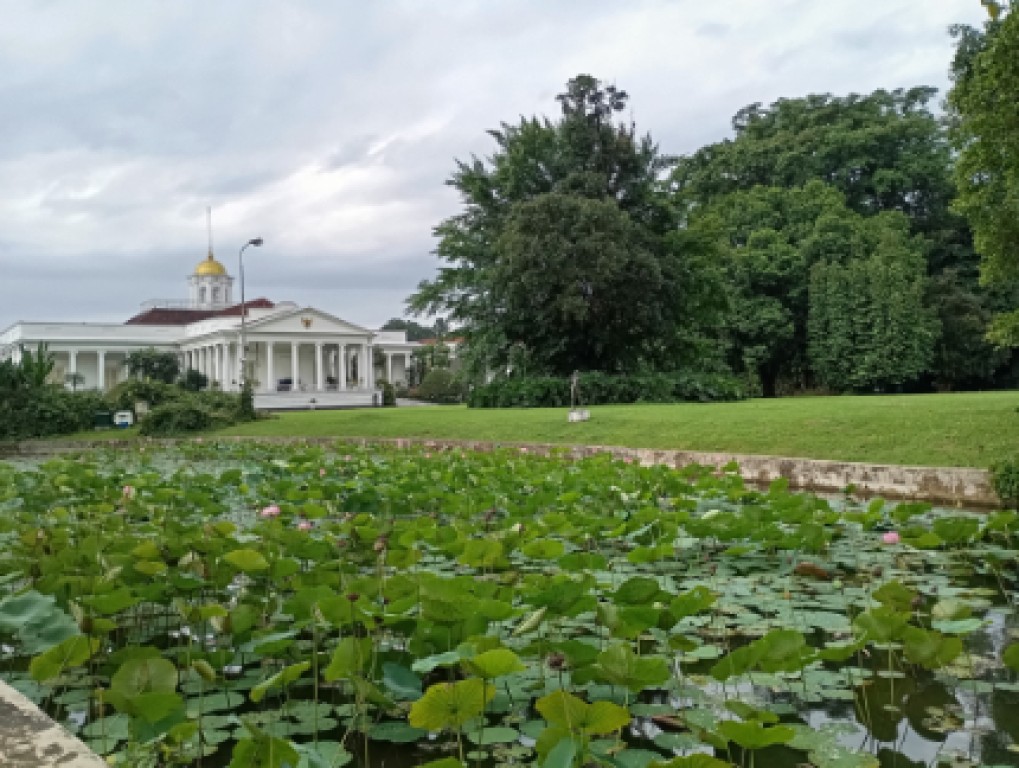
0 437 1000 508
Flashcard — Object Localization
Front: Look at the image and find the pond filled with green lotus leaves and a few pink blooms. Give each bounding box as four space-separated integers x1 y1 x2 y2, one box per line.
0 442 1019 768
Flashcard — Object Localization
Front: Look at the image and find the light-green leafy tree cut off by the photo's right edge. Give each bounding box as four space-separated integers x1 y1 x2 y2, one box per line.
949 3 1019 346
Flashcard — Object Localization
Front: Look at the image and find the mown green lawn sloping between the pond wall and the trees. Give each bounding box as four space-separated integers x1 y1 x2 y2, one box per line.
41 392 1019 468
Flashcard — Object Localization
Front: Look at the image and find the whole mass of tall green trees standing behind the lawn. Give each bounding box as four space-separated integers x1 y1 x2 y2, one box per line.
409 64 1019 395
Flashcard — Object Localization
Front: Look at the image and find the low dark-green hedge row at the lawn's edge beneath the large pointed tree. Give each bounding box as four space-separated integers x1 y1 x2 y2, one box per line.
469 372 746 407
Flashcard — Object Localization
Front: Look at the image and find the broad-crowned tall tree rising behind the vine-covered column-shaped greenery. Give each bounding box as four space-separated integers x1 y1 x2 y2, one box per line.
672 88 1007 392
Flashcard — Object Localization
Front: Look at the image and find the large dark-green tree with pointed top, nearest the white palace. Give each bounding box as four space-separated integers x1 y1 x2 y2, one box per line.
409 75 717 374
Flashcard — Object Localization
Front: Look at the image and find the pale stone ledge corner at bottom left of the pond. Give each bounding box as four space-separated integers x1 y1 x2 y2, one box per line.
0 681 109 768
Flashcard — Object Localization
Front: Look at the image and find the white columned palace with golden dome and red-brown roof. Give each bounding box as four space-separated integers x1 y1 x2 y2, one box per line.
0 251 420 396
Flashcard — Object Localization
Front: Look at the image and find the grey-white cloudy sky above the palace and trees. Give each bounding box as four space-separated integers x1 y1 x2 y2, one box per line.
0 0 983 330
